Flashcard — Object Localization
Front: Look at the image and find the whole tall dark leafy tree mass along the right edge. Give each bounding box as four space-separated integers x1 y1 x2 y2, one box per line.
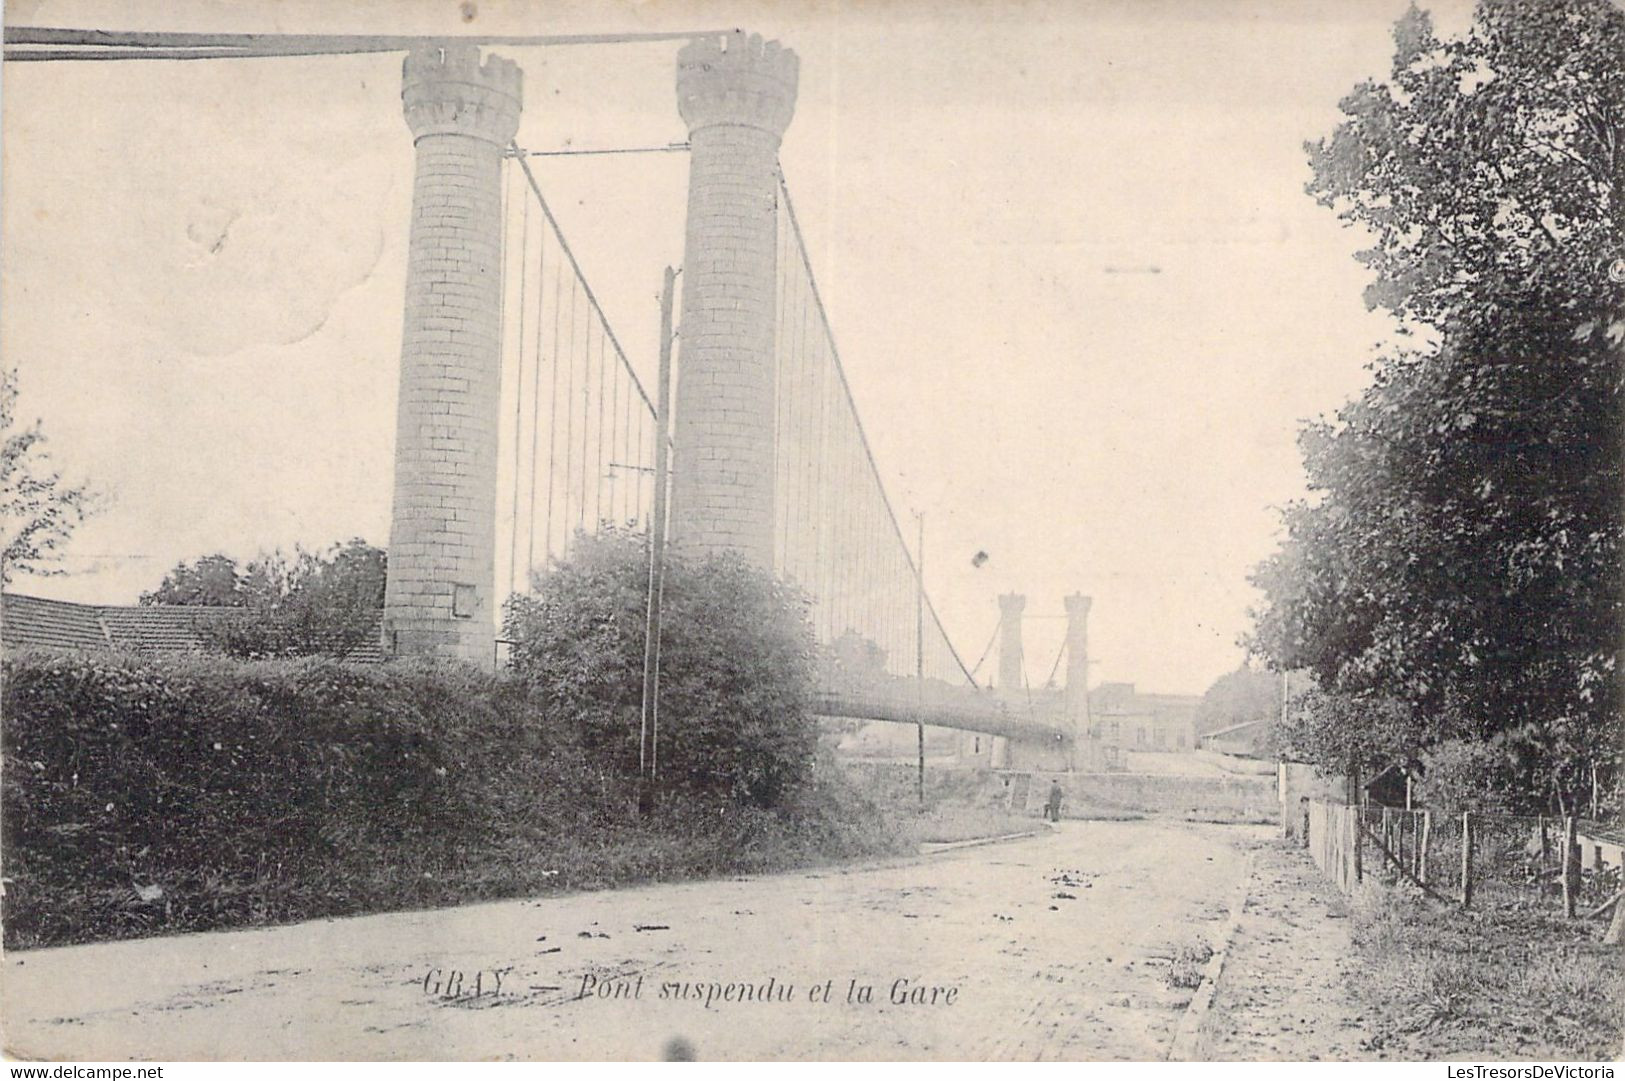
1250 0 1625 801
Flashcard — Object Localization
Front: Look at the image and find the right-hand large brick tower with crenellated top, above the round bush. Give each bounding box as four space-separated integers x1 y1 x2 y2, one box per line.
671 33 798 567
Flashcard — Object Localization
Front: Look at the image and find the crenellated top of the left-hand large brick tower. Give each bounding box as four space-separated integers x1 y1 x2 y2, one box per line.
401 46 522 148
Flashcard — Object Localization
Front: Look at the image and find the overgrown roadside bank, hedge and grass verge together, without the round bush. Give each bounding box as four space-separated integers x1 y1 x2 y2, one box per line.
0 653 942 949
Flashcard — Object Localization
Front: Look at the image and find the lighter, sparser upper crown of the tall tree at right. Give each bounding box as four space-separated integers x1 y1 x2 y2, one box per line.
1307 0 1625 330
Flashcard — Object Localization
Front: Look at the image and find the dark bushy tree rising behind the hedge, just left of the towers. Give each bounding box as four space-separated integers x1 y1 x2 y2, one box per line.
141 538 388 658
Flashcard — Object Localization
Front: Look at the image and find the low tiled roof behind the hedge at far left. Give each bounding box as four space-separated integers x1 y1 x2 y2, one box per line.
0 593 384 663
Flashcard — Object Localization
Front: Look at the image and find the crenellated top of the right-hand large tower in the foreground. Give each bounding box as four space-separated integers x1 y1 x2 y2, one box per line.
678 31 801 137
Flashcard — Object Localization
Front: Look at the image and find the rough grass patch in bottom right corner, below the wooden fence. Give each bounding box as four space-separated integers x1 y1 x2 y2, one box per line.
1352 891 1625 1060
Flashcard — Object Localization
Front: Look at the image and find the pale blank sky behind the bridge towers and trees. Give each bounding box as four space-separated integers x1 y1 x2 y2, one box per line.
0 0 1466 694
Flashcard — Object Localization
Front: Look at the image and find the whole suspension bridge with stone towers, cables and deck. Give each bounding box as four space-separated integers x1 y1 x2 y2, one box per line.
5 28 1087 769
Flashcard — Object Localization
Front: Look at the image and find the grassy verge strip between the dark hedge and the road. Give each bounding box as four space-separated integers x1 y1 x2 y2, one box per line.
5 761 1037 949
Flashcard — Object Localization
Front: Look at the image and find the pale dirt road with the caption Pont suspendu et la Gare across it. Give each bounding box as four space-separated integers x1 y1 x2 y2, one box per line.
0 821 1269 1060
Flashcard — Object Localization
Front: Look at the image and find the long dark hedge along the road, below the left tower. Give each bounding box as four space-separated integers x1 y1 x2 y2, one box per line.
0 653 590 944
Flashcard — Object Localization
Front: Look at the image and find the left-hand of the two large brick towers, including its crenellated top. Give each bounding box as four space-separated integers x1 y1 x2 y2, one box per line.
384 46 520 668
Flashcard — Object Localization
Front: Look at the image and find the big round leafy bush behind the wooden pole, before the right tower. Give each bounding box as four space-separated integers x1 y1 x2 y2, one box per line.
504 532 817 806
